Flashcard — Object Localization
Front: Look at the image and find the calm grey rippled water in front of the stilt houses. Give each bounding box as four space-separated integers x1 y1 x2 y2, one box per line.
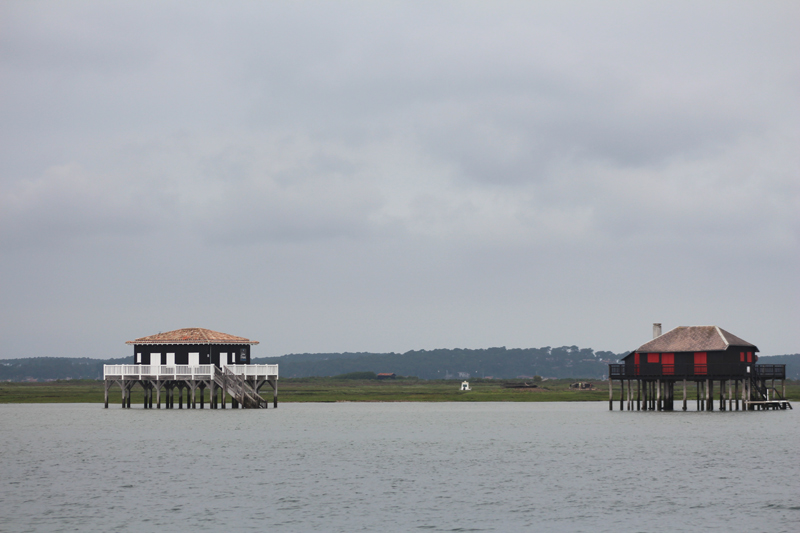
0 402 800 532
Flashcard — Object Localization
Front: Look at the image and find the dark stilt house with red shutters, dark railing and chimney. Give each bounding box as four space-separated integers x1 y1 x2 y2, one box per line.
608 324 792 411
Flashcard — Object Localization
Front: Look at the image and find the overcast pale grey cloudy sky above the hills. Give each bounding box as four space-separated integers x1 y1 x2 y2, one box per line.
0 0 800 358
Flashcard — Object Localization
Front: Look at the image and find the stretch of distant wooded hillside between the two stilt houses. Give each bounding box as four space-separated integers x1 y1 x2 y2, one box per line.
253 346 624 379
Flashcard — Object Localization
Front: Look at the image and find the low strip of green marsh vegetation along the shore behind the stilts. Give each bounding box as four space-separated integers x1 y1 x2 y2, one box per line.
0 378 800 406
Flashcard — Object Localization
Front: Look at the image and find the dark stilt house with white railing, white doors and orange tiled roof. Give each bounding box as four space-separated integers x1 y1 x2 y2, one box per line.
103 328 278 409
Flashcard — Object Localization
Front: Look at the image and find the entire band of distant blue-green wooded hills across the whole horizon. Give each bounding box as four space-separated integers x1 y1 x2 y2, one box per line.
0 346 800 381
